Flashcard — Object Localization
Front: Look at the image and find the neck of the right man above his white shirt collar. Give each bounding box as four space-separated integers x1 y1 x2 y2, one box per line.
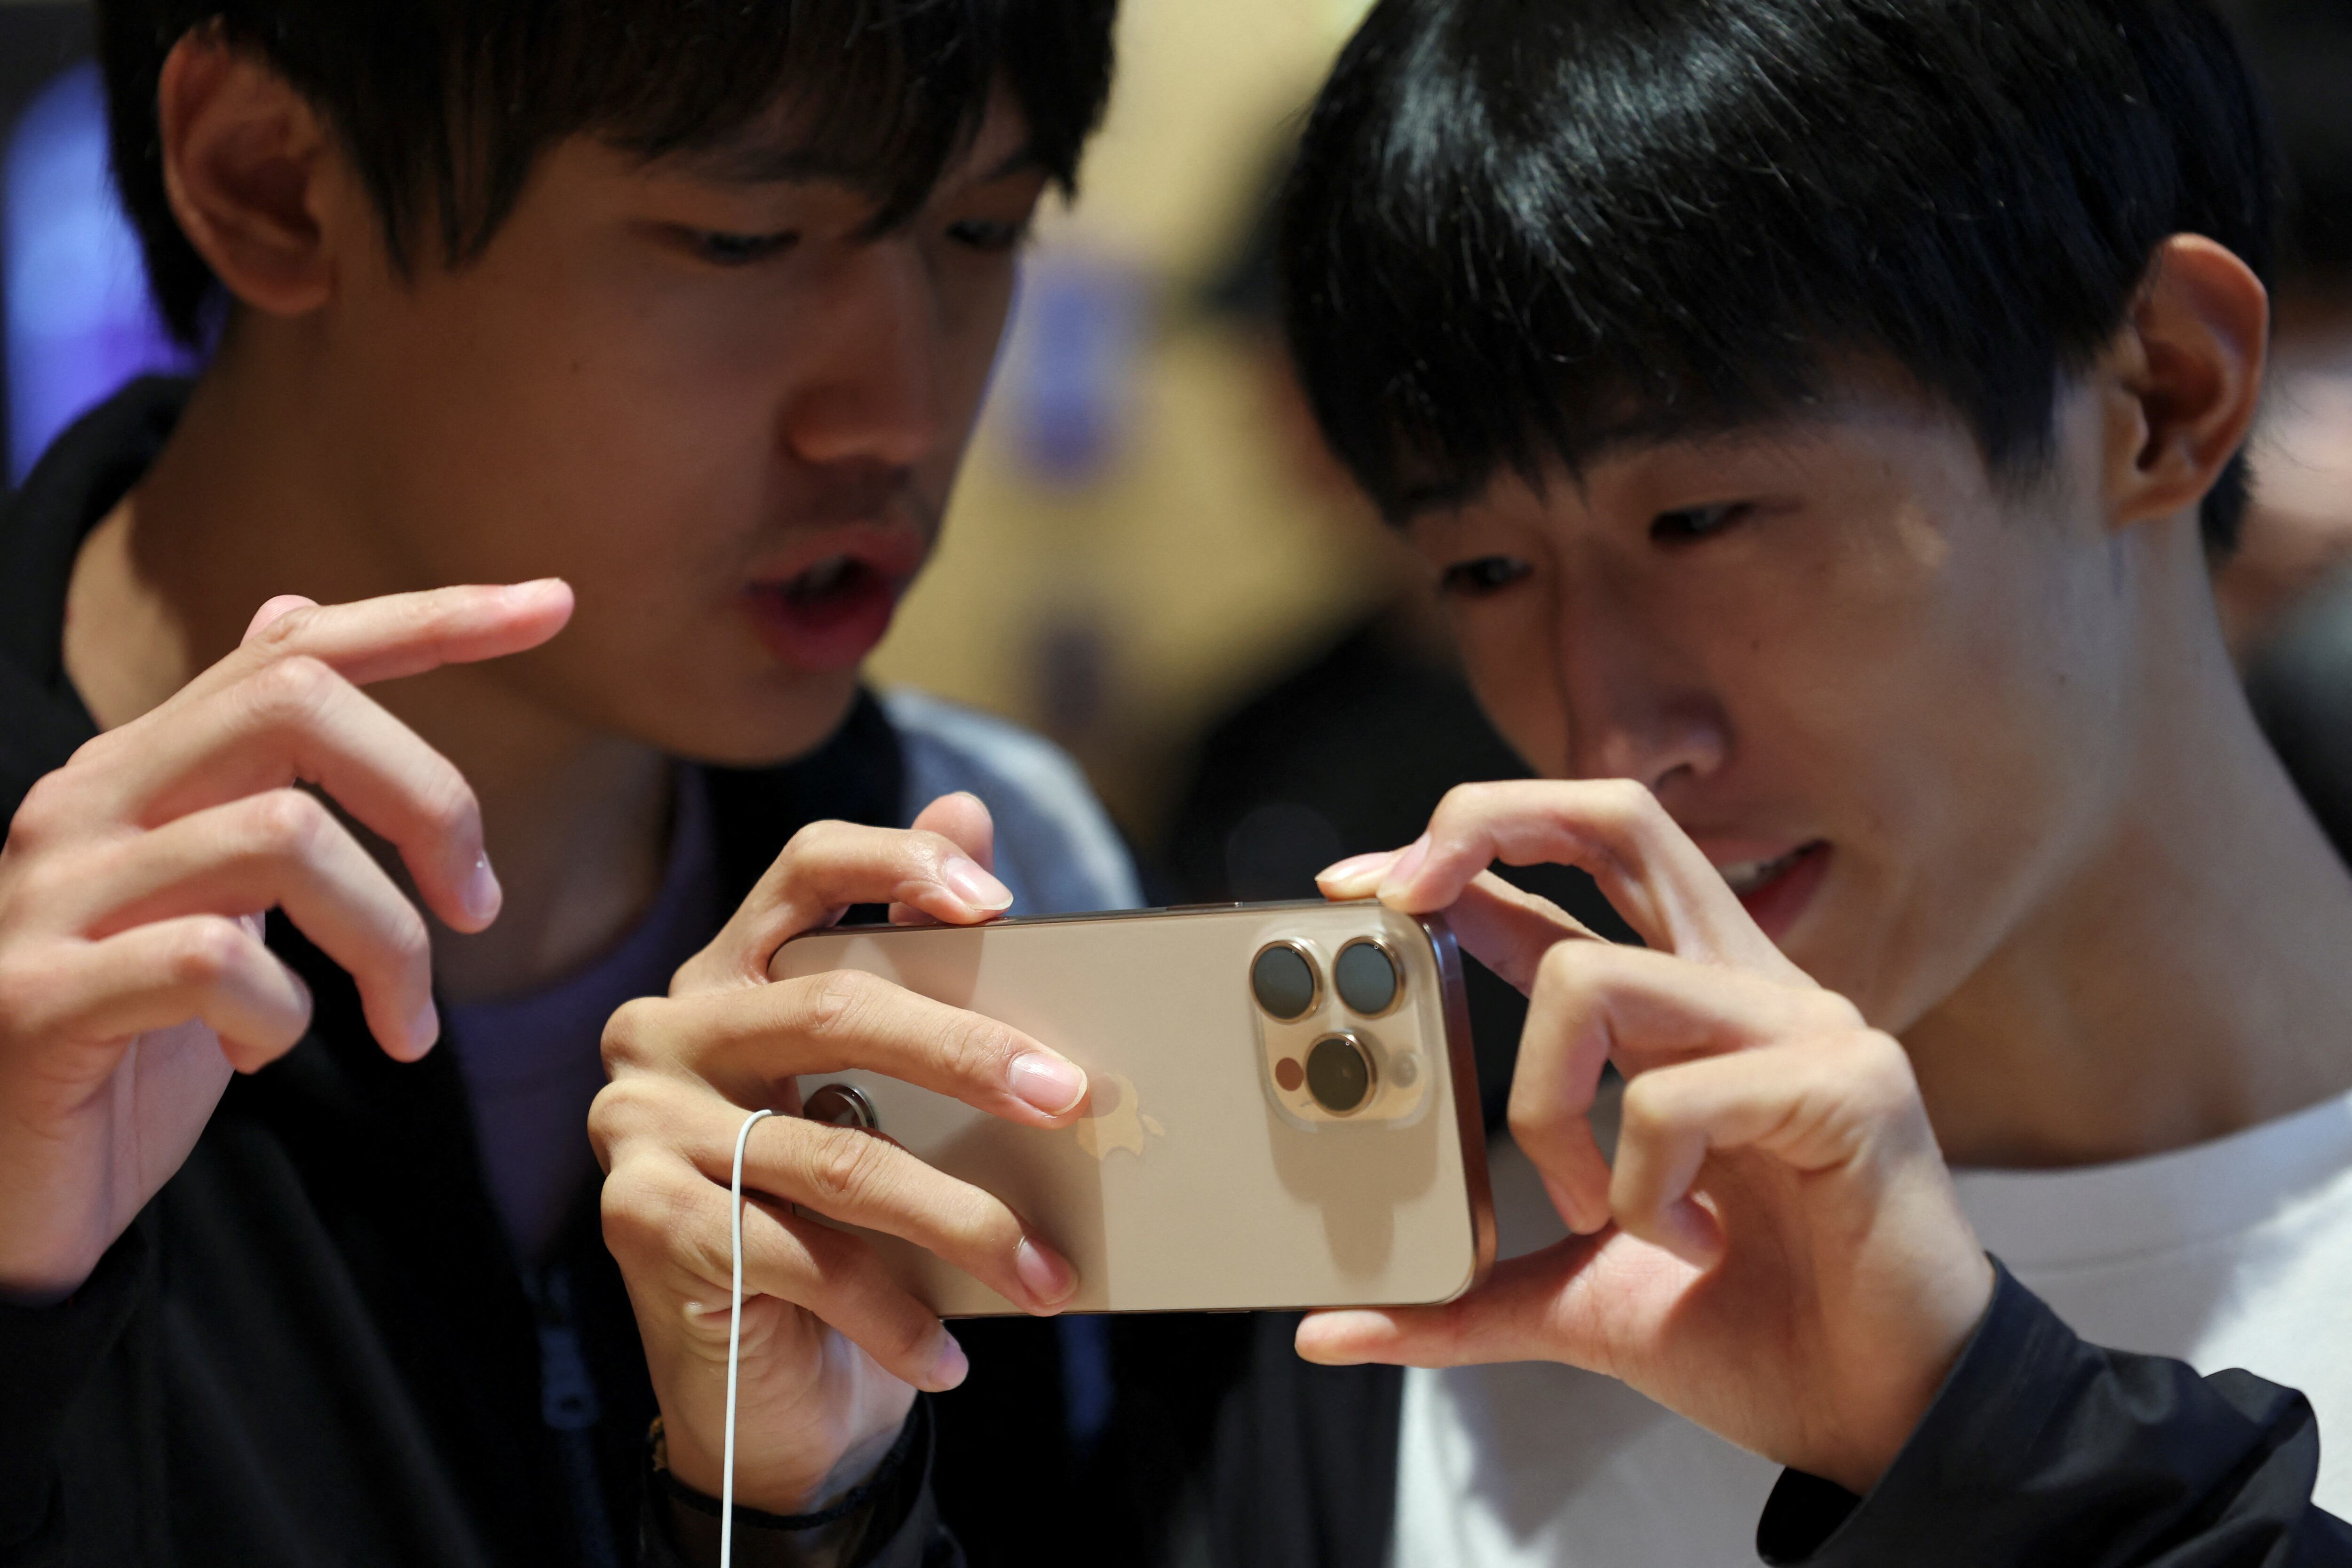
1903 536 2352 1168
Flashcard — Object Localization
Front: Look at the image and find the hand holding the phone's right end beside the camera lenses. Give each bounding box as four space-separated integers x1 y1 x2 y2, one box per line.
1298 781 1992 1490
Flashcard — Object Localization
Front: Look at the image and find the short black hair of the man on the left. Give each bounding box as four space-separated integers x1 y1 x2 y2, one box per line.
99 0 1117 343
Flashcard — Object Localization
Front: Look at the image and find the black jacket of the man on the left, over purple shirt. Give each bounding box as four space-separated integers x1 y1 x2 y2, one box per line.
0 381 927 1568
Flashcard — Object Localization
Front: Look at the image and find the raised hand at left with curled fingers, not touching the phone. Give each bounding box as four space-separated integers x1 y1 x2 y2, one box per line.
0 581 572 1302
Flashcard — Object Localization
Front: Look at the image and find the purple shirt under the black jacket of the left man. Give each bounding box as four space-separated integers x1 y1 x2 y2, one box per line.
442 767 720 1267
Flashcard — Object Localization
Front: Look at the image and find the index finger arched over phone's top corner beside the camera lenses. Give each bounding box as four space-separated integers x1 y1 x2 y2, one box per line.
1345 778 1802 978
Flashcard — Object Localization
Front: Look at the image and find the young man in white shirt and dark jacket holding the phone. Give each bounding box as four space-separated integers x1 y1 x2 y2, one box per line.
654 0 2352 1568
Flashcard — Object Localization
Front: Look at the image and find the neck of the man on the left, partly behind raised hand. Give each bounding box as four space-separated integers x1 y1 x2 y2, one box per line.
66 334 670 1001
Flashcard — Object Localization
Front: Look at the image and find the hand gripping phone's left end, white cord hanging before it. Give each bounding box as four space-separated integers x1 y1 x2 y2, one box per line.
590 794 1087 1514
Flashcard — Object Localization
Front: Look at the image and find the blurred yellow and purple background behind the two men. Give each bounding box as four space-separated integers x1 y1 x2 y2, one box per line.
14 0 2352 903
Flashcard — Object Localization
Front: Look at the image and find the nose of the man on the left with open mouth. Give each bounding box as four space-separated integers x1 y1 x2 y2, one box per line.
783 240 948 468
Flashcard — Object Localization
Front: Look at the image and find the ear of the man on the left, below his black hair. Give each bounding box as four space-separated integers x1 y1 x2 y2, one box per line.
155 26 334 315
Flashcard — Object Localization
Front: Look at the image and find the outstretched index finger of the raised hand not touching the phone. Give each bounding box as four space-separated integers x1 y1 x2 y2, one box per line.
172 578 572 705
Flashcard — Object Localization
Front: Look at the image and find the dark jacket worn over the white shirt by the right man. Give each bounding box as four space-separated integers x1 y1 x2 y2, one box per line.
1211 1269 2352 1568
